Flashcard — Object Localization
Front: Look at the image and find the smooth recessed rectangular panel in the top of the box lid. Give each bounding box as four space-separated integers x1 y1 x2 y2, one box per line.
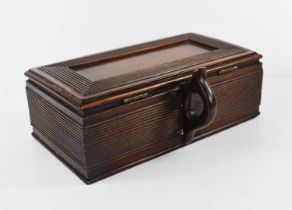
71 41 214 82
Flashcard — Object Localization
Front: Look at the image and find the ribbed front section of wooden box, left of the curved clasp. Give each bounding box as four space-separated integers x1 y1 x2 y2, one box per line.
84 93 183 179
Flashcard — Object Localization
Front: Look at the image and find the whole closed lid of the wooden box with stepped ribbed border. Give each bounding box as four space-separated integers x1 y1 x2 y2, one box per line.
25 33 259 110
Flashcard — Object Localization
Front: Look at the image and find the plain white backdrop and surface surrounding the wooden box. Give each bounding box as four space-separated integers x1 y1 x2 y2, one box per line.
0 0 292 210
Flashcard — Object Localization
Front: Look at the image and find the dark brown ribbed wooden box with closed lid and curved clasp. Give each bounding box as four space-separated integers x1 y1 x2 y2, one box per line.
25 34 263 183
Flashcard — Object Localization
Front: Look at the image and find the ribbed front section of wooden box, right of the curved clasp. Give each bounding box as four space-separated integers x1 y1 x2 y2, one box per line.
199 63 263 135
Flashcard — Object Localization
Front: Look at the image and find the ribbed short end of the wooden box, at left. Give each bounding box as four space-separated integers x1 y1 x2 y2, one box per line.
26 88 86 167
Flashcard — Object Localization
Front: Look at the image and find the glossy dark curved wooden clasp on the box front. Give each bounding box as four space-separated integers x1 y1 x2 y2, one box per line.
184 67 217 144
